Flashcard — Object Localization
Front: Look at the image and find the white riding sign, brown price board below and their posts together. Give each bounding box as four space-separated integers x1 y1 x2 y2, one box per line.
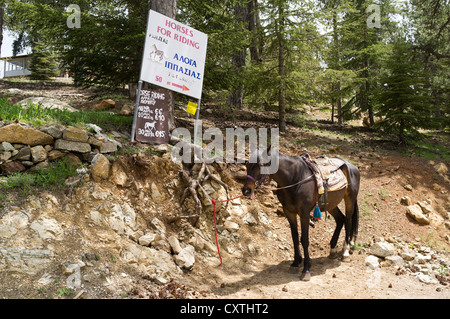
131 10 208 143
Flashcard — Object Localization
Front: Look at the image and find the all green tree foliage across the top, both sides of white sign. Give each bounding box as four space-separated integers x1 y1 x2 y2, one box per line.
0 0 450 136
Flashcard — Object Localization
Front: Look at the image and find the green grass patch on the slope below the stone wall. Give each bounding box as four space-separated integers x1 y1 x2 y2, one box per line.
0 159 76 196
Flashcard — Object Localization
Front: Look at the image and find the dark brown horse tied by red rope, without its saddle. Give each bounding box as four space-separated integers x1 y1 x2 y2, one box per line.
242 150 360 281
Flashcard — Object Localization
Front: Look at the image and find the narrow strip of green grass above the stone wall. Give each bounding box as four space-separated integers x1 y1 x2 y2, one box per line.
0 97 133 128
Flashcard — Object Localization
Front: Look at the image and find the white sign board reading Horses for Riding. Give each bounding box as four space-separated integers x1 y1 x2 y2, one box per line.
140 10 208 99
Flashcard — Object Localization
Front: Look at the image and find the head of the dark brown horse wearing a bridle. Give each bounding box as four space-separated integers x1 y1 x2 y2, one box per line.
242 150 269 199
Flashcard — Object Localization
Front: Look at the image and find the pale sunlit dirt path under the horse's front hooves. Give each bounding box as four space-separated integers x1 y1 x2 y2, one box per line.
203 252 450 299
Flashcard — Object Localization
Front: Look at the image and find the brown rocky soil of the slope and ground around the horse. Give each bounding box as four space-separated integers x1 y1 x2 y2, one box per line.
0 79 450 299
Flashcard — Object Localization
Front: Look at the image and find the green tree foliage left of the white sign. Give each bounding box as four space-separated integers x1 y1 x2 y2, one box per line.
6 0 148 87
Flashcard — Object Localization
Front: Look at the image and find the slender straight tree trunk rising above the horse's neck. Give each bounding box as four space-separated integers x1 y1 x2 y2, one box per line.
276 1 286 132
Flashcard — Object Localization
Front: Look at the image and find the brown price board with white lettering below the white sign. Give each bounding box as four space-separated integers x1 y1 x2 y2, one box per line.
136 90 169 144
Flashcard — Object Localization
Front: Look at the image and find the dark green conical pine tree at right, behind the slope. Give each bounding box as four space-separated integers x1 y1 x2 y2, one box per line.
377 38 431 143
